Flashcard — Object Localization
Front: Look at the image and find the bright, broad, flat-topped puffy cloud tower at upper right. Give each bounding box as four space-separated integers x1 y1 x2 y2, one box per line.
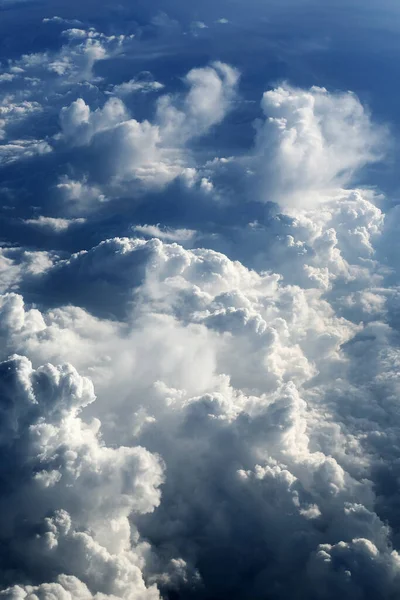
255 84 385 208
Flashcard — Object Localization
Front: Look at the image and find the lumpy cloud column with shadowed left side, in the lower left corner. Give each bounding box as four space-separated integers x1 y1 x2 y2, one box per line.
0 356 162 598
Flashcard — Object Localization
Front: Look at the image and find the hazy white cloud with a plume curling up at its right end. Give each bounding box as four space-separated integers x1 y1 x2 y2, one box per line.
59 63 238 195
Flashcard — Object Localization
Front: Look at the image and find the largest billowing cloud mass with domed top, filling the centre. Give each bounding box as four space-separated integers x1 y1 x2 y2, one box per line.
2 194 398 598
